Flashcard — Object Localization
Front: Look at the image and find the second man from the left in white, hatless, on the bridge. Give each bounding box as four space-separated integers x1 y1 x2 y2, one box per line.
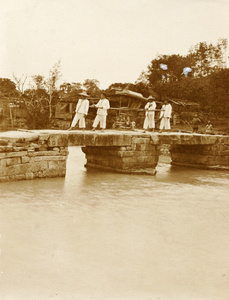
92 93 110 131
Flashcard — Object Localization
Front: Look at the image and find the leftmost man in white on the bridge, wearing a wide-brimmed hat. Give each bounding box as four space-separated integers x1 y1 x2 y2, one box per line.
68 92 89 130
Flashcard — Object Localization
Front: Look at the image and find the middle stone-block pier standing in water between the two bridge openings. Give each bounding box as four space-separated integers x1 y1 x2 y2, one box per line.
82 137 160 175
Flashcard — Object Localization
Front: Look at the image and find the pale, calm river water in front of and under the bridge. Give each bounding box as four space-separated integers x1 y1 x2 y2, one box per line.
0 147 229 300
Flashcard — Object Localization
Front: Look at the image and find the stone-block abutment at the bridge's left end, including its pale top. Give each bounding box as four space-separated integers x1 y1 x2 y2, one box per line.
0 132 68 182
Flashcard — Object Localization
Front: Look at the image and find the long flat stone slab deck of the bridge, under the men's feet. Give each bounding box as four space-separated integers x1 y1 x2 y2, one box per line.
0 130 229 146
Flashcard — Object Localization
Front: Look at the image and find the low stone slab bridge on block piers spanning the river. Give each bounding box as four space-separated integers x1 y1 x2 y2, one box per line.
0 130 229 182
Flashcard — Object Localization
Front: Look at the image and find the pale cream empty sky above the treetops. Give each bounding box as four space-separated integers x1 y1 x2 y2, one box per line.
0 0 229 89
